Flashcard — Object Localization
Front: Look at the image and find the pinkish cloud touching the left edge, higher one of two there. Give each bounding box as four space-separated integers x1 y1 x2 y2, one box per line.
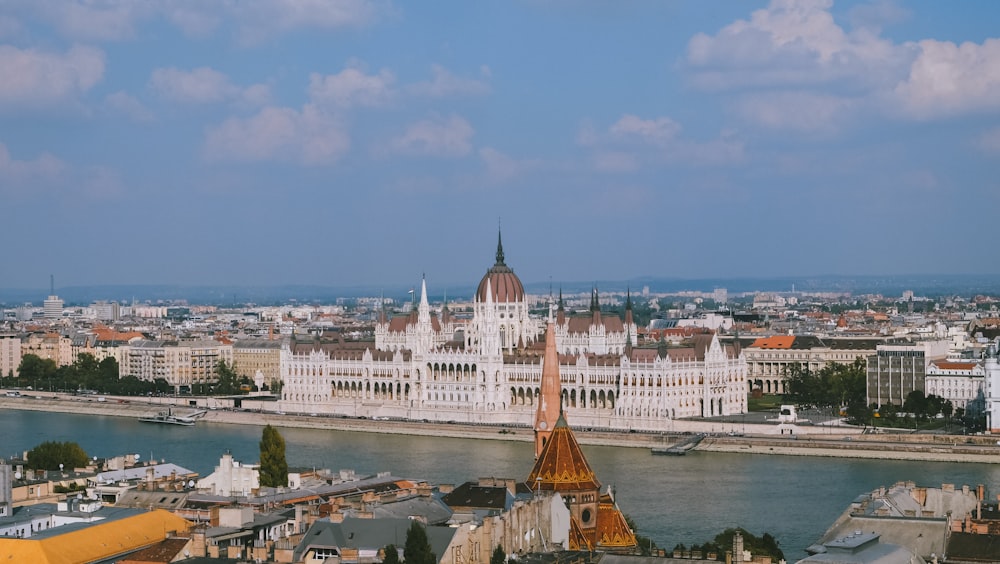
0 45 104 107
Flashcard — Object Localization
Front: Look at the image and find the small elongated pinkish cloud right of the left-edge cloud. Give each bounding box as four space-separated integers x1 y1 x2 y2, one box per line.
149 67 270 106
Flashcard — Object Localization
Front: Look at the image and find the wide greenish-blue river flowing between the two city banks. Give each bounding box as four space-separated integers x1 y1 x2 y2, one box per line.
0 410 1000 562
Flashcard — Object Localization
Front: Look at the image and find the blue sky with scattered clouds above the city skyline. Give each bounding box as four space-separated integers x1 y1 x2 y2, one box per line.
0 0 1000 291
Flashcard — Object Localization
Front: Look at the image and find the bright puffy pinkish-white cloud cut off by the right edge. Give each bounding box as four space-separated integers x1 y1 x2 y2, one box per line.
895 39 1000 119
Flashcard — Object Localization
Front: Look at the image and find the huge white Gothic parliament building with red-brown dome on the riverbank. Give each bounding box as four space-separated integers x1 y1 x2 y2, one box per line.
280 234 747 430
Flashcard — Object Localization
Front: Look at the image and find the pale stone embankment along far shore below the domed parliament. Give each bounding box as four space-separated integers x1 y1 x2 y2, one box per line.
0 392 1000 464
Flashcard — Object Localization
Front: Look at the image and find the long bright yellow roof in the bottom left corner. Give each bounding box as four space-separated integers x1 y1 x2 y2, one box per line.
0 509 191 564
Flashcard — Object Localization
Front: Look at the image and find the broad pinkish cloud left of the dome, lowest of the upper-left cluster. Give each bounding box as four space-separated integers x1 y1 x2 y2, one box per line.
204 104 351 165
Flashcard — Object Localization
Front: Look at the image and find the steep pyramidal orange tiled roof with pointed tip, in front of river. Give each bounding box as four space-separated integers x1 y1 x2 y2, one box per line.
525 415 601 492
